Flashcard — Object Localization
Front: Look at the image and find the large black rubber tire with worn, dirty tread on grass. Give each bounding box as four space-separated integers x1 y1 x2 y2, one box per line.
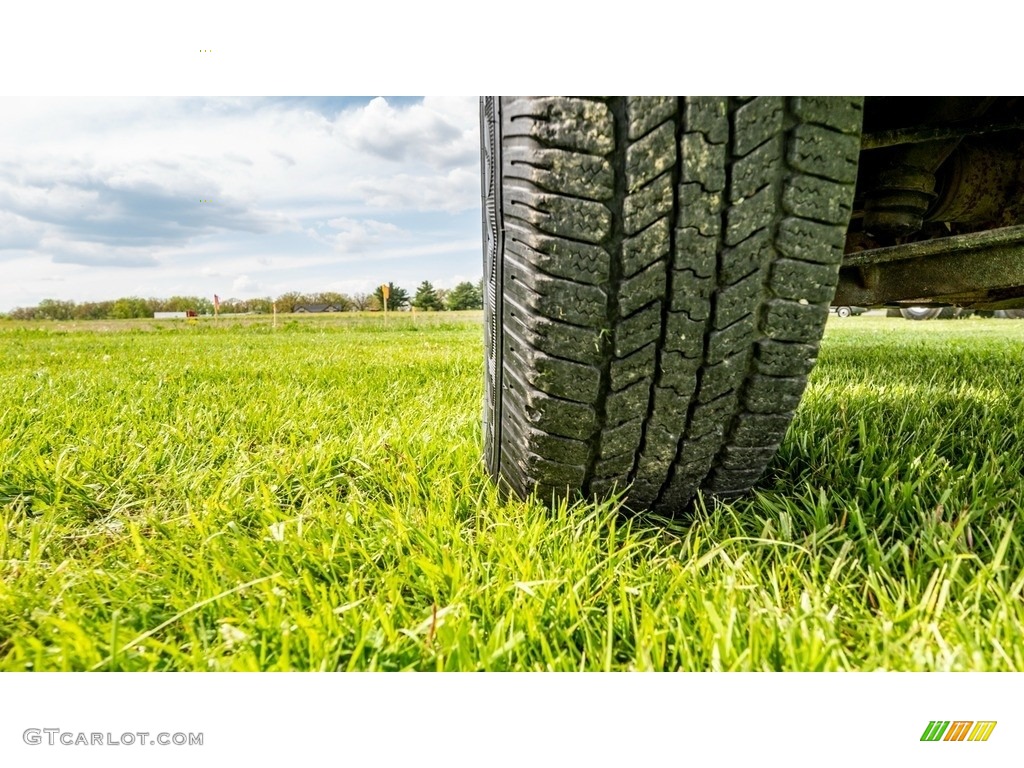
481 96 861 514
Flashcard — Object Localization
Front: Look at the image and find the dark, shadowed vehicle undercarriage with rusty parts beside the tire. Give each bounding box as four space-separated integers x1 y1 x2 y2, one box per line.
833 96 1024 310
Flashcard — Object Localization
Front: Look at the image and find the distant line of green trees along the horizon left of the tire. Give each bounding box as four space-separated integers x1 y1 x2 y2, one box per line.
0 280 483 321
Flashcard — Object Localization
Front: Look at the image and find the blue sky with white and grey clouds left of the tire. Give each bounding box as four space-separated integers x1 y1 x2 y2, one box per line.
0 96 481 311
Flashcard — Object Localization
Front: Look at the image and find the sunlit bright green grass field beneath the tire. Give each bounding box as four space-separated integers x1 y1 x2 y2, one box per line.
0 313 1024 671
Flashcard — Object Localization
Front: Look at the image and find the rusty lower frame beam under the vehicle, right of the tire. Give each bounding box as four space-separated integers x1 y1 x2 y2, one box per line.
833 225 1024 309
